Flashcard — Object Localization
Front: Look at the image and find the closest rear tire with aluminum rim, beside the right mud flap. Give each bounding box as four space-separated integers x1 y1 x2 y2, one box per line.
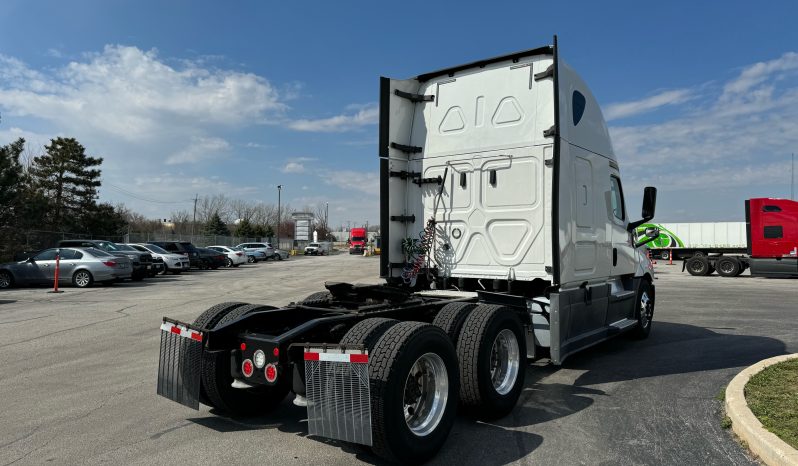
369 322 459 463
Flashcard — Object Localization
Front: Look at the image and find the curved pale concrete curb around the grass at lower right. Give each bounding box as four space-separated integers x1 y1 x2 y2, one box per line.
726 354 798 466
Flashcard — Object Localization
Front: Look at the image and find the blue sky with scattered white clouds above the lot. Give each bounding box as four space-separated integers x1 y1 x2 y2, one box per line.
0 0 798 225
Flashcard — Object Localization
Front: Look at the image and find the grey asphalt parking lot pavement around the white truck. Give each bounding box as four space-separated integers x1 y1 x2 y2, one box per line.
0 254 798 465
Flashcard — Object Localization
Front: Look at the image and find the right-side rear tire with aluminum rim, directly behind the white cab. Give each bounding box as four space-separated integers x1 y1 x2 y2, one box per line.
457 304 526 419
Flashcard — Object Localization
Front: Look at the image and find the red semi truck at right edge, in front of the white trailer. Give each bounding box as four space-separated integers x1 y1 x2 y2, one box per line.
638 198 798 277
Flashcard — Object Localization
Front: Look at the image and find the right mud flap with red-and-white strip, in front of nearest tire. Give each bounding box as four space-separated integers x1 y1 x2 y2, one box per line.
304 348 372 446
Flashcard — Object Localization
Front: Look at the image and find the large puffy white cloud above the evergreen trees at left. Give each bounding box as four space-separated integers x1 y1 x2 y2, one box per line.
0 45 286 140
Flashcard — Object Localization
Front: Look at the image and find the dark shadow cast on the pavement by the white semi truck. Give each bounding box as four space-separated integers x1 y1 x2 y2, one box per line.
189 321 786 464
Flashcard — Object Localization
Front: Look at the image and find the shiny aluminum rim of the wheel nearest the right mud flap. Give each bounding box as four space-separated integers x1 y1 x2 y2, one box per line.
403 353 449 437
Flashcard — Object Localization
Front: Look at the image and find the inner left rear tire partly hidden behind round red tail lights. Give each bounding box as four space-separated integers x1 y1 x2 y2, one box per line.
201 304 291 417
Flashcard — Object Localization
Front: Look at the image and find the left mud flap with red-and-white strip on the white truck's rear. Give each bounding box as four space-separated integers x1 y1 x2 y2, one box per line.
158 320 203 409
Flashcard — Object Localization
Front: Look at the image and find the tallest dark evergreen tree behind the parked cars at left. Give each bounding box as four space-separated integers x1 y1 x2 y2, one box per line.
30 137 103 230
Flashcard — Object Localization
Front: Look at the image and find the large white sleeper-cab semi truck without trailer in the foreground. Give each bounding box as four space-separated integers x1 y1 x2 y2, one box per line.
158 38 658 462
